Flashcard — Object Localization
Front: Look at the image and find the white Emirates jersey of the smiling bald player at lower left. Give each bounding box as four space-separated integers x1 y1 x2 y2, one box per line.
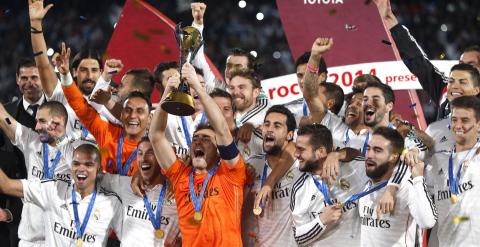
21 180 122 247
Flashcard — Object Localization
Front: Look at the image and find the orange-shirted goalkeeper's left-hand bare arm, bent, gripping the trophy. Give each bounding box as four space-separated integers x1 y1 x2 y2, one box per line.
149 74 180 171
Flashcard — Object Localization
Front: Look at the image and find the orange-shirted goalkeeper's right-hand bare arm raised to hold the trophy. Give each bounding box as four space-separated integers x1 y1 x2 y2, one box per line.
182 63 240 166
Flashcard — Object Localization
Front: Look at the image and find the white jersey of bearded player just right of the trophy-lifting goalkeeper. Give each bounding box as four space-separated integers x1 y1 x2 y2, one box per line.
244 155 300 246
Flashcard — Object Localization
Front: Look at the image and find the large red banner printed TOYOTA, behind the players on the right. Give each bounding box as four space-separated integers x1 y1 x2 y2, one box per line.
277 0 426 128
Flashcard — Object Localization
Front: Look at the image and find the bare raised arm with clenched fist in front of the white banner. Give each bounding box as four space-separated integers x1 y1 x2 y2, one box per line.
302 38 333 123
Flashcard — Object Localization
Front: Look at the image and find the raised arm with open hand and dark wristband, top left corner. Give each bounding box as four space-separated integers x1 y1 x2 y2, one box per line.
28 0 58 97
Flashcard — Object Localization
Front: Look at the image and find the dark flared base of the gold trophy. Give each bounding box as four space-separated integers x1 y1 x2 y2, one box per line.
161 92 195 116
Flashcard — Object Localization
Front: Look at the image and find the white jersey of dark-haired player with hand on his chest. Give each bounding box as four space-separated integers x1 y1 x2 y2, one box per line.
290 157 368 246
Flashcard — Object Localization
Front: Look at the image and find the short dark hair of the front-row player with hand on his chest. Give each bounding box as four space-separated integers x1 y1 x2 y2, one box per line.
297 124 333 153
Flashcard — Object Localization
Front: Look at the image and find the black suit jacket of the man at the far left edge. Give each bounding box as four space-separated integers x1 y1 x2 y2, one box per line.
0 98 36 247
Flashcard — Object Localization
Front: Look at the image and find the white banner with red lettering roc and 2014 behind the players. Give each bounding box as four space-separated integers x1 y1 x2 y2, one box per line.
262 60 458 105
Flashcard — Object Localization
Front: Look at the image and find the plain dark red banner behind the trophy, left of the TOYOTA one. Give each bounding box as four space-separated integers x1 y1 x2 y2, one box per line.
106 0 221 102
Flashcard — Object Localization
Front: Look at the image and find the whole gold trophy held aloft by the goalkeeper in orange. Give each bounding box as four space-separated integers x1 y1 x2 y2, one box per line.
162 23 203 116
